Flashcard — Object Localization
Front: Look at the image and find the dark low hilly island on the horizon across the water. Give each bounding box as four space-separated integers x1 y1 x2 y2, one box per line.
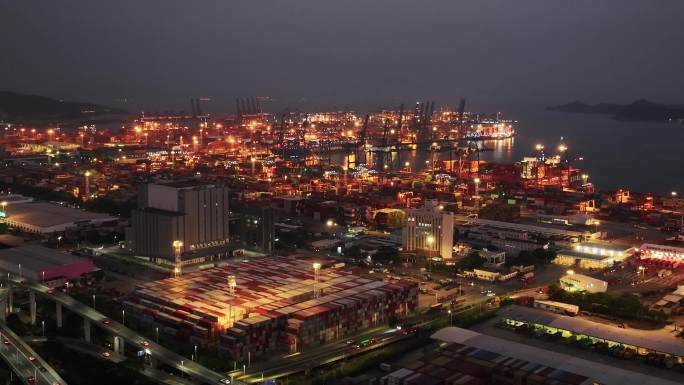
547 99 684 123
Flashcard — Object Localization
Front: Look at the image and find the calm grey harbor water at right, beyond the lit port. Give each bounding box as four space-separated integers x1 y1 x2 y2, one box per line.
335 108 684 195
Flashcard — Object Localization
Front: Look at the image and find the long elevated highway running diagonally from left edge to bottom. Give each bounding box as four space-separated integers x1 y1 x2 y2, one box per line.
12 277 239 385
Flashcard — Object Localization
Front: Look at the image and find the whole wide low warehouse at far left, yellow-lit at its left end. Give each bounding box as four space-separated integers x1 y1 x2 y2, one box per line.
2 201 118 235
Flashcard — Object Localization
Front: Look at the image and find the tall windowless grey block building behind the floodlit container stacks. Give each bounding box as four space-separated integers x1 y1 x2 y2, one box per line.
126 181 229 263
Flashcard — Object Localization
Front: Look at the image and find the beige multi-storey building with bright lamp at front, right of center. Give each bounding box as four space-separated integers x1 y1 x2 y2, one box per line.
402 200 454 259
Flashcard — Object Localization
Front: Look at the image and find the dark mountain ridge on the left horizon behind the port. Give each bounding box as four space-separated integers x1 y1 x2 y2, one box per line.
0 91 126 122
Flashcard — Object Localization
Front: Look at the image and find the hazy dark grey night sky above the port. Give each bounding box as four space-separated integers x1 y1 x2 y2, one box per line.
0 0 684 112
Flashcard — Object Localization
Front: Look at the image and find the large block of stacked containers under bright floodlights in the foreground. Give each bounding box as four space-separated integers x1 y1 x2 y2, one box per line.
124 257 418 357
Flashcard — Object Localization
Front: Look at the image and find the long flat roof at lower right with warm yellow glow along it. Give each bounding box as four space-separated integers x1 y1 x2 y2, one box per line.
499 305 684 357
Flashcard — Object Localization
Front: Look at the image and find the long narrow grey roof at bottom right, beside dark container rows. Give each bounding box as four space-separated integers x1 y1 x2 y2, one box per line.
432 327 681 385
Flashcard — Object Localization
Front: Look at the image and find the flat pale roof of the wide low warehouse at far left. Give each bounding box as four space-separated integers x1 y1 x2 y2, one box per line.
7 202 116 227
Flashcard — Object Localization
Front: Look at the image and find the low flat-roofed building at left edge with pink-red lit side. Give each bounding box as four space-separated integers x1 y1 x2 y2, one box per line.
0 245 97 286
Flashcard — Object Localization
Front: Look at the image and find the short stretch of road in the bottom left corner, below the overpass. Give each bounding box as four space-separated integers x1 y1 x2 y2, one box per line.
0 324 66 385
